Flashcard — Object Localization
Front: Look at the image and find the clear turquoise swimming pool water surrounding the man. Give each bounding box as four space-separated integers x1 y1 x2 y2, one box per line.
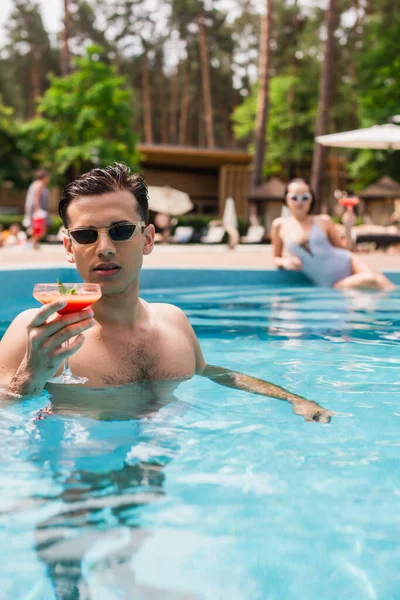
0 272 400 600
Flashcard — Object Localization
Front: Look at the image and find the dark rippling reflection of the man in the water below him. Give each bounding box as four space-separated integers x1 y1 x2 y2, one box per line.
2 381 189 599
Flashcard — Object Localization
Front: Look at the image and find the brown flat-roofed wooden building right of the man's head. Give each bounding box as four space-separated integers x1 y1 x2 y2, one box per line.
138 144 251 218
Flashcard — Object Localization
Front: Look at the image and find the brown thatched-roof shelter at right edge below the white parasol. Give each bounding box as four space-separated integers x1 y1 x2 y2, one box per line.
358 176 400 225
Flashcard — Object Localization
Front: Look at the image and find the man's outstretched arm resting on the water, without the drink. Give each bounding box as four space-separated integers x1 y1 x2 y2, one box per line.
186 319 334 423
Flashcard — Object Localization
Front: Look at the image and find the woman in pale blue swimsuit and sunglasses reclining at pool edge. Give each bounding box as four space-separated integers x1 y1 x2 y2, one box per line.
271 179 395 290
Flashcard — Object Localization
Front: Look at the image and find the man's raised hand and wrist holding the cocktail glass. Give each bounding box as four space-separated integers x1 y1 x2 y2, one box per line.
9 300 95 395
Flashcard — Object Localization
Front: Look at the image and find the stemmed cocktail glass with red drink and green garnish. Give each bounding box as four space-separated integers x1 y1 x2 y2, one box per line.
33 283 101 384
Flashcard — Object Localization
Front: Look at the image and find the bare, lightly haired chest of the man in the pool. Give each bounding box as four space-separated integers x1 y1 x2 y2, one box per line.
71 332 196 387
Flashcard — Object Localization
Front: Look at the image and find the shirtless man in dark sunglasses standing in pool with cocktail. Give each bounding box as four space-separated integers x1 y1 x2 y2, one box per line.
0 164 332 423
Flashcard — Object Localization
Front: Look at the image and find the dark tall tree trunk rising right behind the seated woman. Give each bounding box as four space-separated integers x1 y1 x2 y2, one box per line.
311 0 336 210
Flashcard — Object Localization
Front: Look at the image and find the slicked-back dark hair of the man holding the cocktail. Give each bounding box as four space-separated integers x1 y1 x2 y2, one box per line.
58 163 149 227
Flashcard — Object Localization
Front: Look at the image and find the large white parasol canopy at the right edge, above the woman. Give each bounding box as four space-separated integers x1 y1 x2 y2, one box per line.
315 123 400 150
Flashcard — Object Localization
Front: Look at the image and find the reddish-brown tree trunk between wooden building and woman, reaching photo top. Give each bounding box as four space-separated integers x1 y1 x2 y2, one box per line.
251 0 272 187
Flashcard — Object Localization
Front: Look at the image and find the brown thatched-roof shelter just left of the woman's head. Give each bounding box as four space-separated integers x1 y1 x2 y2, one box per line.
248 177 286 237
